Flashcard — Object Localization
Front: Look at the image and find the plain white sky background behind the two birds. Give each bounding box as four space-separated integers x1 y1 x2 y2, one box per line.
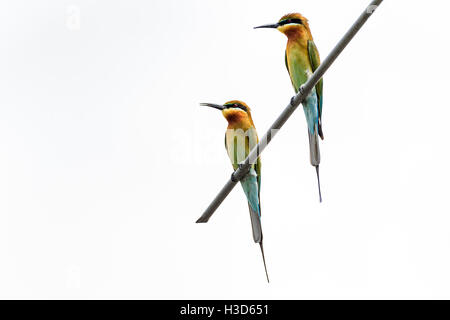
0 0 450 299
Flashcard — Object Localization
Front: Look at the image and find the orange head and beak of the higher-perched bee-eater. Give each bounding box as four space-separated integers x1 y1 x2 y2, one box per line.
255 13 312 40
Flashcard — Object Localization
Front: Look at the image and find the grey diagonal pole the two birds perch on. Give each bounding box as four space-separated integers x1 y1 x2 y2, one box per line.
197 0 383 223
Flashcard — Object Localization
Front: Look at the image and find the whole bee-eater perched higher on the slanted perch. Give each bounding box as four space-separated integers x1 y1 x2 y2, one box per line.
255 13 323 202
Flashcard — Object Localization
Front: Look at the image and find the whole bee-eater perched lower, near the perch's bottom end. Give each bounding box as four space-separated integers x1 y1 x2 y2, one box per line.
200 100 269 282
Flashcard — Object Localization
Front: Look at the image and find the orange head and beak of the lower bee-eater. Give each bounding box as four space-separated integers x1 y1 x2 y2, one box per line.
201 100 254 129
